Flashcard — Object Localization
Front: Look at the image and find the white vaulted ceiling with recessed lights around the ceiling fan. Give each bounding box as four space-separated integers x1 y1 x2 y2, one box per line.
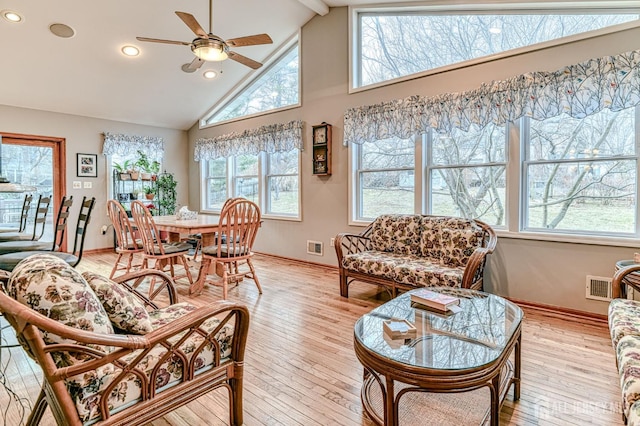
0 0 400 129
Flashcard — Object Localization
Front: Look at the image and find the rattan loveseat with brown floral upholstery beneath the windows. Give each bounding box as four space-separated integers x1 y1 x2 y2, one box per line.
334 214 497 297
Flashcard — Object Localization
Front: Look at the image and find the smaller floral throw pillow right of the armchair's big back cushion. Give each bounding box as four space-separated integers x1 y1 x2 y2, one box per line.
82 272 153 334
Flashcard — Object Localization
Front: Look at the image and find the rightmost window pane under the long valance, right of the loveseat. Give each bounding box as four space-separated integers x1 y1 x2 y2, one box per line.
522 108 638 234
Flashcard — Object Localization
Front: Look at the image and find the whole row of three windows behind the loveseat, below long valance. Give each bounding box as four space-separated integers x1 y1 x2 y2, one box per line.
352 108 640 239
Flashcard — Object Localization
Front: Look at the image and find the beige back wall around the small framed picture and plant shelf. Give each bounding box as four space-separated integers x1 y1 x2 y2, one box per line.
0 105 193 250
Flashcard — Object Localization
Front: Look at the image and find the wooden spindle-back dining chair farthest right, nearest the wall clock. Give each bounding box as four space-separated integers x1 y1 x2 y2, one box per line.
195 198 262 299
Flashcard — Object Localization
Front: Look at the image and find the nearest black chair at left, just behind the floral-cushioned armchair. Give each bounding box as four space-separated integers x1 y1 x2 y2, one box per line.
0 197 96 271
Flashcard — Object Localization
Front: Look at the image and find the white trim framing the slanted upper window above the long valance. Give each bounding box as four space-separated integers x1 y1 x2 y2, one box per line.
348 1 640 94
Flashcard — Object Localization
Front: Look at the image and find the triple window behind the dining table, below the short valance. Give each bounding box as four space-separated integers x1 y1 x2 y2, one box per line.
201 149 300 219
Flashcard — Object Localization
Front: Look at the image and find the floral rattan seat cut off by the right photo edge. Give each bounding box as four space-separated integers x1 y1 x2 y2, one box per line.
608 263 640 426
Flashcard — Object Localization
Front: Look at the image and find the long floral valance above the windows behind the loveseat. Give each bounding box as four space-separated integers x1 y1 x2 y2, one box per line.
344 50 640 146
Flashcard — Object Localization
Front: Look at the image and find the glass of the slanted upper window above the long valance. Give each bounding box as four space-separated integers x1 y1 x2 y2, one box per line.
352 8 638 88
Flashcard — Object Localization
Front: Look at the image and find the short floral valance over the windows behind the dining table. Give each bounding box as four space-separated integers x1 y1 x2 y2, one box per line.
194 120 302 161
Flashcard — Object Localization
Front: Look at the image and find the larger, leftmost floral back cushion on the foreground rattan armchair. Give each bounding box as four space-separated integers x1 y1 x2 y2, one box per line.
7 254 113 343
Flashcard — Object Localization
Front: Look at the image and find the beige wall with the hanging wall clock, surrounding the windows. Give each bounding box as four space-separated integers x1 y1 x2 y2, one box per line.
188 8 640 313
